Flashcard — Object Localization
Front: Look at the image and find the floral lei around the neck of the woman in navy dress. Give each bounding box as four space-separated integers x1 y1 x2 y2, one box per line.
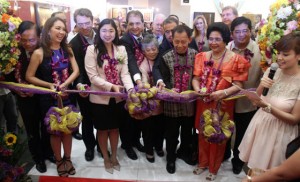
51 48 69 90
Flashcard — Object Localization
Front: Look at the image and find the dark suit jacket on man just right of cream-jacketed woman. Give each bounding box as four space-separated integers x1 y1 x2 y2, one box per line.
121 33 141 78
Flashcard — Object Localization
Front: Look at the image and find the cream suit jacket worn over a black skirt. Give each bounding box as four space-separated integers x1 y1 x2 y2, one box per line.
85 45 133 105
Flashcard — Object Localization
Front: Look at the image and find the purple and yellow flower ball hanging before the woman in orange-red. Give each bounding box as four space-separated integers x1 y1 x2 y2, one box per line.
200 109 234 143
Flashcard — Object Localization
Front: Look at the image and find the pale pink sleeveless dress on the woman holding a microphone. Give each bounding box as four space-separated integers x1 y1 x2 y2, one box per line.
239 69 300 170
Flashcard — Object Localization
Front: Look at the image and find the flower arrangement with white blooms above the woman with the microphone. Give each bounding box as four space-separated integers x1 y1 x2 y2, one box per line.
258 0 300 70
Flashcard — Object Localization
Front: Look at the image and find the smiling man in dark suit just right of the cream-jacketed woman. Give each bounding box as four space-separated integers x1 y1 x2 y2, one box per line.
120 11 144 160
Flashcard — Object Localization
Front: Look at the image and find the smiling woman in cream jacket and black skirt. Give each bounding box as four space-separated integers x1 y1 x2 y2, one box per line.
85 19 133 174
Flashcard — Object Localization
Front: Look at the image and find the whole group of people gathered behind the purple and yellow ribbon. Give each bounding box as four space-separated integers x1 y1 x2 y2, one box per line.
1 3 300 181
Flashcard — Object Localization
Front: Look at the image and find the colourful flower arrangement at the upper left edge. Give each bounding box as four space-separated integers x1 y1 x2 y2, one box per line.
0 0 22 74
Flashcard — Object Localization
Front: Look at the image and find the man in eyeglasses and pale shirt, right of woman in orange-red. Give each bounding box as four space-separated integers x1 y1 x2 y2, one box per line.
227 16 263 174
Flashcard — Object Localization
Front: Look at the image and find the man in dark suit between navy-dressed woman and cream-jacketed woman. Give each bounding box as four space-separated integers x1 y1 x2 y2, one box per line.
70 8 97 161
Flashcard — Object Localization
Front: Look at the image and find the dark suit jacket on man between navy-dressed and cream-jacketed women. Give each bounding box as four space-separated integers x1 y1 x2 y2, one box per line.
70 33 91 87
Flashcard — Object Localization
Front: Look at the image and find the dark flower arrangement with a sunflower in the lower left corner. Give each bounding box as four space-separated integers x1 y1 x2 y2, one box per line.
0 130 26 181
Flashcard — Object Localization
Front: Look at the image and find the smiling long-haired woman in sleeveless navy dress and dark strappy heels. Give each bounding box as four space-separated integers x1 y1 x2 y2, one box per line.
26 17 79 176
